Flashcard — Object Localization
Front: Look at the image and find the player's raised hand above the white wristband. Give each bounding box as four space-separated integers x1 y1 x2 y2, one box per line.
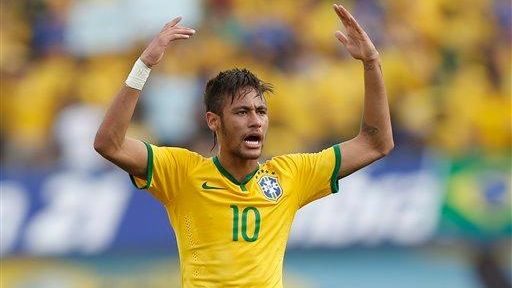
140 17 196 68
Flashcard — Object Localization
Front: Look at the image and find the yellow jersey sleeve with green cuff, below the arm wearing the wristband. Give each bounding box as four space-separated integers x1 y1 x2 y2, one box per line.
130 142 201 204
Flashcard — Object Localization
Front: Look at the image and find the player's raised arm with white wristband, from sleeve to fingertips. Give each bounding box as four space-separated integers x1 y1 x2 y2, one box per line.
94 17 195 179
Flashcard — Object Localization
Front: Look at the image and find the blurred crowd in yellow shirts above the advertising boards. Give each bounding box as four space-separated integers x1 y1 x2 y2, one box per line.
0 0 512 168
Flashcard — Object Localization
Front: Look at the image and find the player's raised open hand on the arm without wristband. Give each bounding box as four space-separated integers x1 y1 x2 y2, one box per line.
333 4 379 62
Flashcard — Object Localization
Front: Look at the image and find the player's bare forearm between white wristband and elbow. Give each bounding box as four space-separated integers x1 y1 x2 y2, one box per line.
94 85 140 155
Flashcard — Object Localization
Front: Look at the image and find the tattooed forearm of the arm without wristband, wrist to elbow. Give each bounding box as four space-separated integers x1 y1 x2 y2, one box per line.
359 58 393 154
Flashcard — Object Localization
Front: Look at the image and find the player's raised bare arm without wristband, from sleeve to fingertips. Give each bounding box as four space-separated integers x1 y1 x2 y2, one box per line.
333 4 394 178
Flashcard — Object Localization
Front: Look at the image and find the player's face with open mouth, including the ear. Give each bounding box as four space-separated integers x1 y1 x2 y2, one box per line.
207 89 268 160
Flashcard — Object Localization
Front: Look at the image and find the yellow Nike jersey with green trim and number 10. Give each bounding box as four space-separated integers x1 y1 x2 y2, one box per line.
130 143 341 288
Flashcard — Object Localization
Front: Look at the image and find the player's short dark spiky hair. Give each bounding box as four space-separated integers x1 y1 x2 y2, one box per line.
204 68 273 115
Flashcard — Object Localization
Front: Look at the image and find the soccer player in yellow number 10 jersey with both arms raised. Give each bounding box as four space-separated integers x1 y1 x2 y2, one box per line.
94 5 393 287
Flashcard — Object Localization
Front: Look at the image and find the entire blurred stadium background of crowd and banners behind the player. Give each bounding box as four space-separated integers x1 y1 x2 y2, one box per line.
0 0 512 288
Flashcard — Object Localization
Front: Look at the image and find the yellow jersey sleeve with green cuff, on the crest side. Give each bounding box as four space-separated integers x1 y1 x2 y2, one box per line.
278 144 341 207
